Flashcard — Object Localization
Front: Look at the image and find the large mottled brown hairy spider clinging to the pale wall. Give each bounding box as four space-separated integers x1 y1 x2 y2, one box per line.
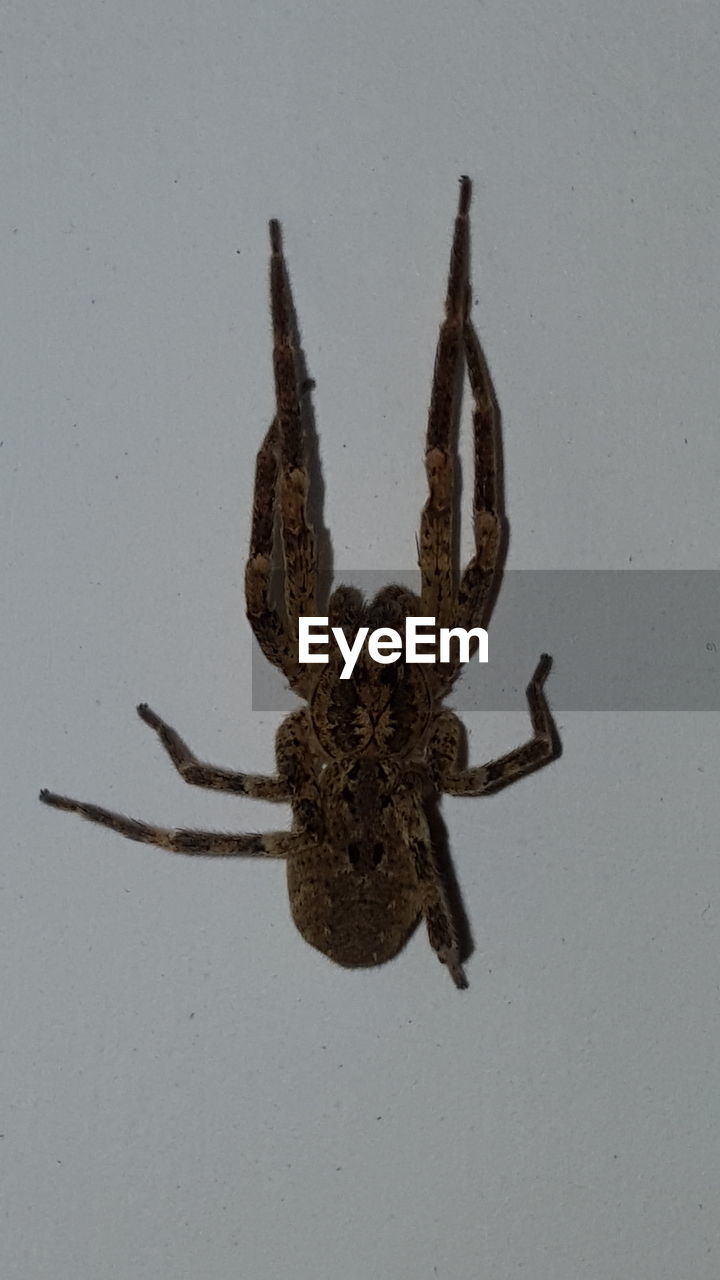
40 177 560 988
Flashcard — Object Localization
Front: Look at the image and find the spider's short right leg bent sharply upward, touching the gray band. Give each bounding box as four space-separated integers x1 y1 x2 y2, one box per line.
427 653 560 796
